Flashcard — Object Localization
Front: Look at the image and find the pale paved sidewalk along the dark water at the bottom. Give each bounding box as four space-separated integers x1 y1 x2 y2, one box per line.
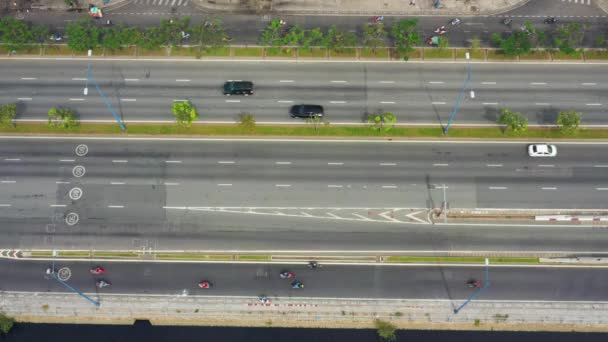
0 290 608 331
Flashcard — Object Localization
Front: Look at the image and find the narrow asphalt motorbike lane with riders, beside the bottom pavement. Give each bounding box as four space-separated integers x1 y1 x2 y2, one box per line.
0 261 608 301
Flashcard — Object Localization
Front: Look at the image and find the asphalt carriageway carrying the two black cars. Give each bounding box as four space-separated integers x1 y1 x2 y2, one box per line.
0 60 608 125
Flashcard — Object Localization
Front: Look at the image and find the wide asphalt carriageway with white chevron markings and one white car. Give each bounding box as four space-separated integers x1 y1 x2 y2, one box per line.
0 138 608 251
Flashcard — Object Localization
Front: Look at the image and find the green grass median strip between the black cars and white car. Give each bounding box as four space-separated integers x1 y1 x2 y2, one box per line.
0 123 608 139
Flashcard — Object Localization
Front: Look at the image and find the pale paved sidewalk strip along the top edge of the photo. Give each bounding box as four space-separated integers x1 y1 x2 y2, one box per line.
195 0 530 16
